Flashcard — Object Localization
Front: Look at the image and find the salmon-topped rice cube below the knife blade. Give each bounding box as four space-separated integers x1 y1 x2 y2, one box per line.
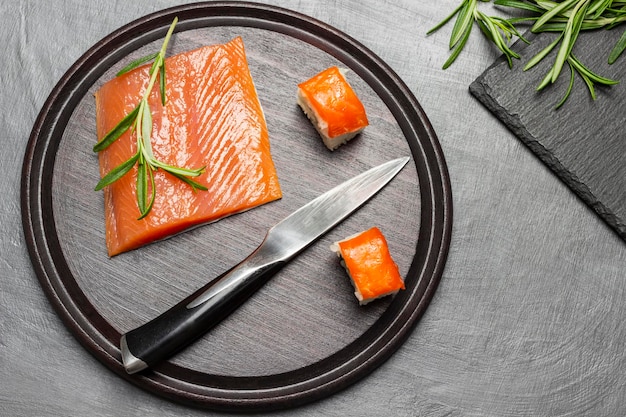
331 227 404 305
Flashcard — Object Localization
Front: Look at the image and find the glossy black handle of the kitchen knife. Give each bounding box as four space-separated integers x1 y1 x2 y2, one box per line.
120 255 286 374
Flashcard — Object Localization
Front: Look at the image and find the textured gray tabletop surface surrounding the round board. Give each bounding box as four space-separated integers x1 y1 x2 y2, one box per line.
0 0 626 416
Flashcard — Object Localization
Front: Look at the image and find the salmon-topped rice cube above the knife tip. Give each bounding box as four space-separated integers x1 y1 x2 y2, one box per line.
298 67 369 151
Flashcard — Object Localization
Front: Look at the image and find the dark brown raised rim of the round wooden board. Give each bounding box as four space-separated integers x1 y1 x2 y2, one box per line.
21 2 452 411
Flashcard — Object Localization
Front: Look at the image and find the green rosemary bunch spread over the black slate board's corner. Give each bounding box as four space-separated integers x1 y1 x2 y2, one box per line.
428 0 626 108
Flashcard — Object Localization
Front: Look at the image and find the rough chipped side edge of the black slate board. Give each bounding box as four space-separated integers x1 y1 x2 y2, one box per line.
469 64 626 241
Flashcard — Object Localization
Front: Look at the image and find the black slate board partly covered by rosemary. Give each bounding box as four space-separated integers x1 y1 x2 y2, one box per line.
470 27 626 239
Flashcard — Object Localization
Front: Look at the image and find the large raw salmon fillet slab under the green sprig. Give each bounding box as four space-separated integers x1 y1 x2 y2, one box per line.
95 38 282 256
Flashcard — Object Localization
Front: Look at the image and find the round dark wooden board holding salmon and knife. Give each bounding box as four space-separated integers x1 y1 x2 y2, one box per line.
22 2 452 411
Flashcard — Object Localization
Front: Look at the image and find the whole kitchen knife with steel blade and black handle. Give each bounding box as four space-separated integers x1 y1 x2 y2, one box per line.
120 157 409 374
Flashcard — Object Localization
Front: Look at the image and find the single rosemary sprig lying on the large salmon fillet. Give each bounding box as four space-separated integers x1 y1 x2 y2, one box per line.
93 18 207 220
